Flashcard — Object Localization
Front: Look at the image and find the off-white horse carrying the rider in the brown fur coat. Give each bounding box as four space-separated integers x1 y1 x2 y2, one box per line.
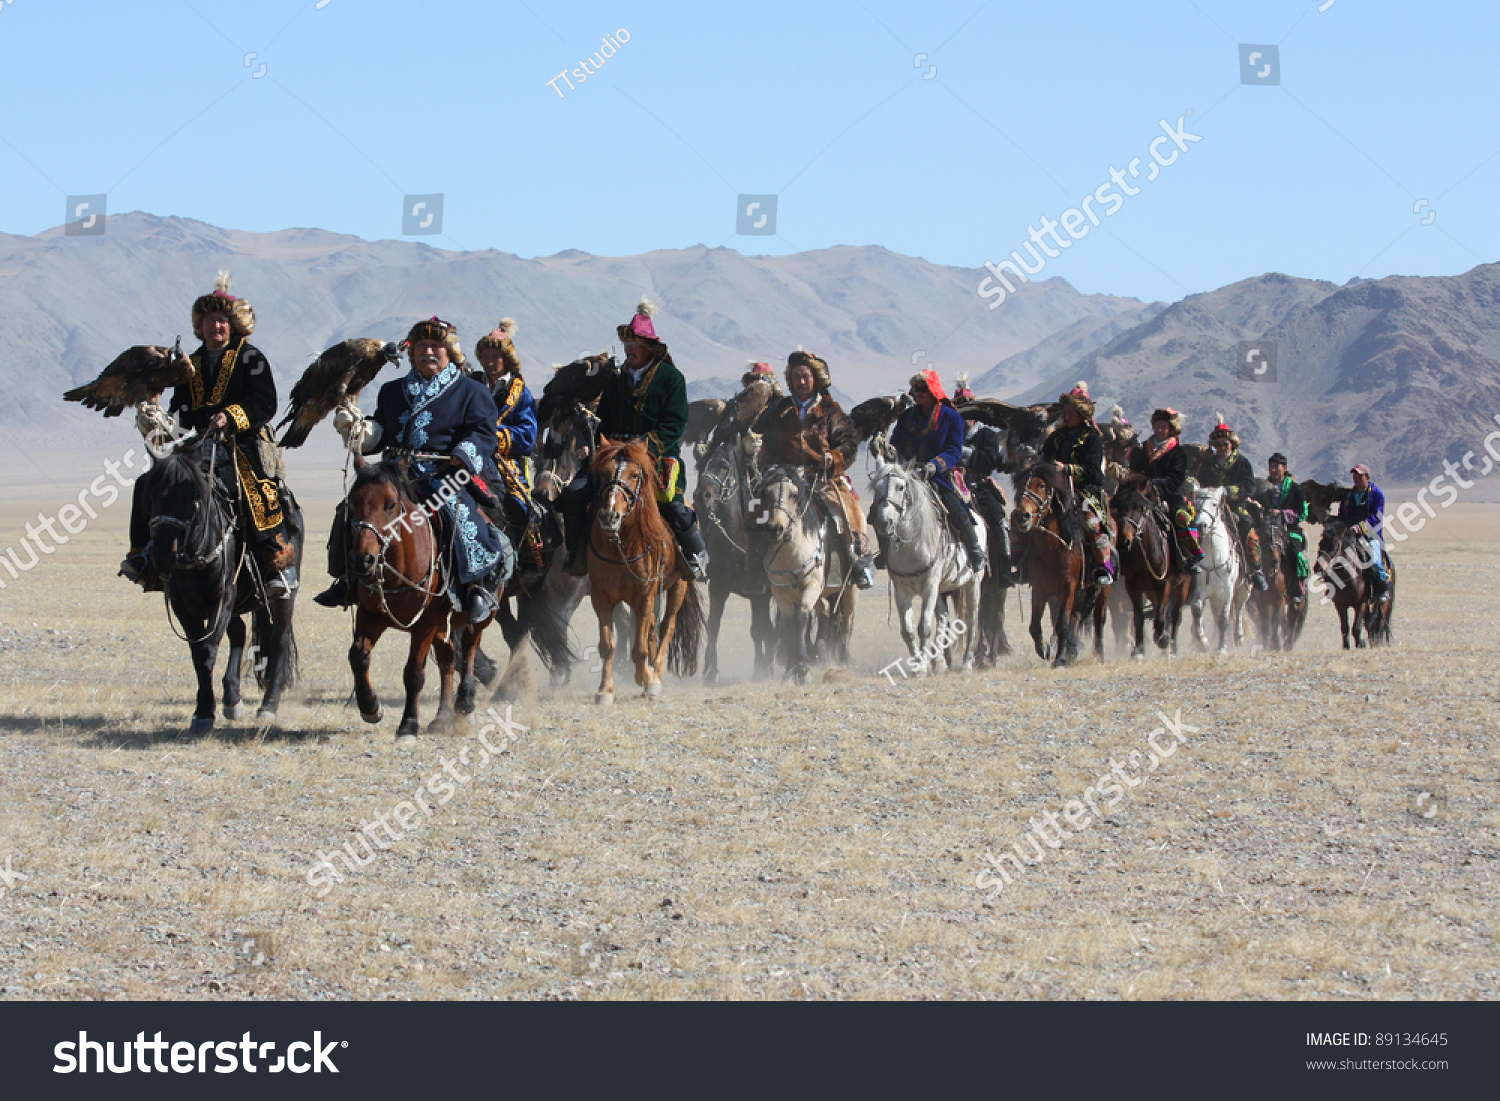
749 467 858 684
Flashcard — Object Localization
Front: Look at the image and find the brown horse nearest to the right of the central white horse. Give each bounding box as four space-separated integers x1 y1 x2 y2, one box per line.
1011 464 1107 669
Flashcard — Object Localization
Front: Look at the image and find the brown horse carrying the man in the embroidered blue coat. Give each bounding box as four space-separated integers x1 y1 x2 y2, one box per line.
348 461 462 738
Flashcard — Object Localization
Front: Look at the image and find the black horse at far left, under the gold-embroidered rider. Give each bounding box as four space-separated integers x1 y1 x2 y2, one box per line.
143 438 303 735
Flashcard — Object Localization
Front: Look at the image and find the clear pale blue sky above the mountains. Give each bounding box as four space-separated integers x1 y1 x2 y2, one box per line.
0 0 1500 299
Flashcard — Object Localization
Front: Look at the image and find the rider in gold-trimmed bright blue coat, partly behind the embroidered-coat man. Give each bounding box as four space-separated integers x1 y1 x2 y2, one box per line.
474 318 545 573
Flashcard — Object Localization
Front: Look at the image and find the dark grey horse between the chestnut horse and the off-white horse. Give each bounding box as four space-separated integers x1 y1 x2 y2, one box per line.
693 437 776 684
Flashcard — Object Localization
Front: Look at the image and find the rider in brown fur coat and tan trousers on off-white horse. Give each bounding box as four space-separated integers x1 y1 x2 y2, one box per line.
750 351 875 588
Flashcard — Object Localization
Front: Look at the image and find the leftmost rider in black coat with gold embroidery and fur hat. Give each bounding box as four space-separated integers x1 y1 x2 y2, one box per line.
120 272 297 600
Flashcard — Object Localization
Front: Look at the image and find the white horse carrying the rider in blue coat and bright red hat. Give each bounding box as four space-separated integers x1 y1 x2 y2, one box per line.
870 450 986 672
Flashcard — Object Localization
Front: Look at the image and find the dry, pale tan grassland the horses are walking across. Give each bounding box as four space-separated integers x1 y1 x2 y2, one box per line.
0 503 1500 999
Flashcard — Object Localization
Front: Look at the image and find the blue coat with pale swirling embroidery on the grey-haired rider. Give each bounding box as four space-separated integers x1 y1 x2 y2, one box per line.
371 363 515 585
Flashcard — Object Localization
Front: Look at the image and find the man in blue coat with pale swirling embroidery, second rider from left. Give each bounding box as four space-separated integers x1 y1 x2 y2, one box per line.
314 318 513 623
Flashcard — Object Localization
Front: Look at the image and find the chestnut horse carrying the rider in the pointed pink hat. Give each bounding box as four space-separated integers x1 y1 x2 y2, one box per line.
587 437 704 704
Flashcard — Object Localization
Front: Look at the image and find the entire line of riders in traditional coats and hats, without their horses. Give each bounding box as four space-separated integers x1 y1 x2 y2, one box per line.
122 270 1386 642
